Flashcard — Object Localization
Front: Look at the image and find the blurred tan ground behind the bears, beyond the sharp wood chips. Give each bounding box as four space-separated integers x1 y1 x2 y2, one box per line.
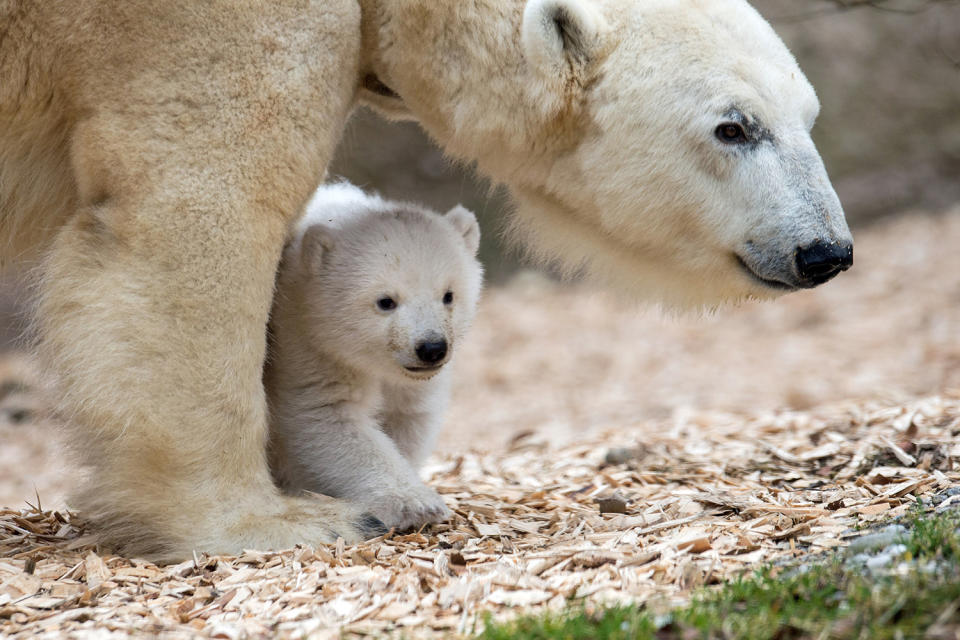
0 207 960 508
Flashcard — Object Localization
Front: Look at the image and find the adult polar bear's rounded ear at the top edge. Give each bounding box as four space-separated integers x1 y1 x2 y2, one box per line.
521 0 602 77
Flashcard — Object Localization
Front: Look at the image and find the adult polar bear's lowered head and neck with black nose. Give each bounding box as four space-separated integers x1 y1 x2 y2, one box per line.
362 0 853 306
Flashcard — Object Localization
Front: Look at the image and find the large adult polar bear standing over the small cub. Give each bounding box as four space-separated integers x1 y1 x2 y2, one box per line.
0 0 852 559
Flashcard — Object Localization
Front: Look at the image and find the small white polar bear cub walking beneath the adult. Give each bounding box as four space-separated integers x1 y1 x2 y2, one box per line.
264 184 482 528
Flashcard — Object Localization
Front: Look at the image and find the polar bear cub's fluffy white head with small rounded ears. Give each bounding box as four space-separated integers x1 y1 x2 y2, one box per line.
305 207 482 382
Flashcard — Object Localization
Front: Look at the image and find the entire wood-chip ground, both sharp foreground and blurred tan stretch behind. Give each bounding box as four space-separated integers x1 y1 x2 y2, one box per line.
0 208 960 638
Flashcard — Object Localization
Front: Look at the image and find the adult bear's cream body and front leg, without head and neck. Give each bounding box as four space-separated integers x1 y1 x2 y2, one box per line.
0 0 382 559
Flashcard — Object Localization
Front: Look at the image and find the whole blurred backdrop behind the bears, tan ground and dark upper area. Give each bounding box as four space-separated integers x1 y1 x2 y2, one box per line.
0 0 960 506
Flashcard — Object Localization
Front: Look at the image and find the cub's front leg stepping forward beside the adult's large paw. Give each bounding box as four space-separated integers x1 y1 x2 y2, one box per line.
275 407 450 529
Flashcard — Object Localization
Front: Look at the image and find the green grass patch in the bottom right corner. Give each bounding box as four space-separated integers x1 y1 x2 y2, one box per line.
479 512 960 640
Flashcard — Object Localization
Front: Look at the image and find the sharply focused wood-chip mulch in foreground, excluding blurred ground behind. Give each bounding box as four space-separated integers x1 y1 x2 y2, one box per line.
0 396 960 638
